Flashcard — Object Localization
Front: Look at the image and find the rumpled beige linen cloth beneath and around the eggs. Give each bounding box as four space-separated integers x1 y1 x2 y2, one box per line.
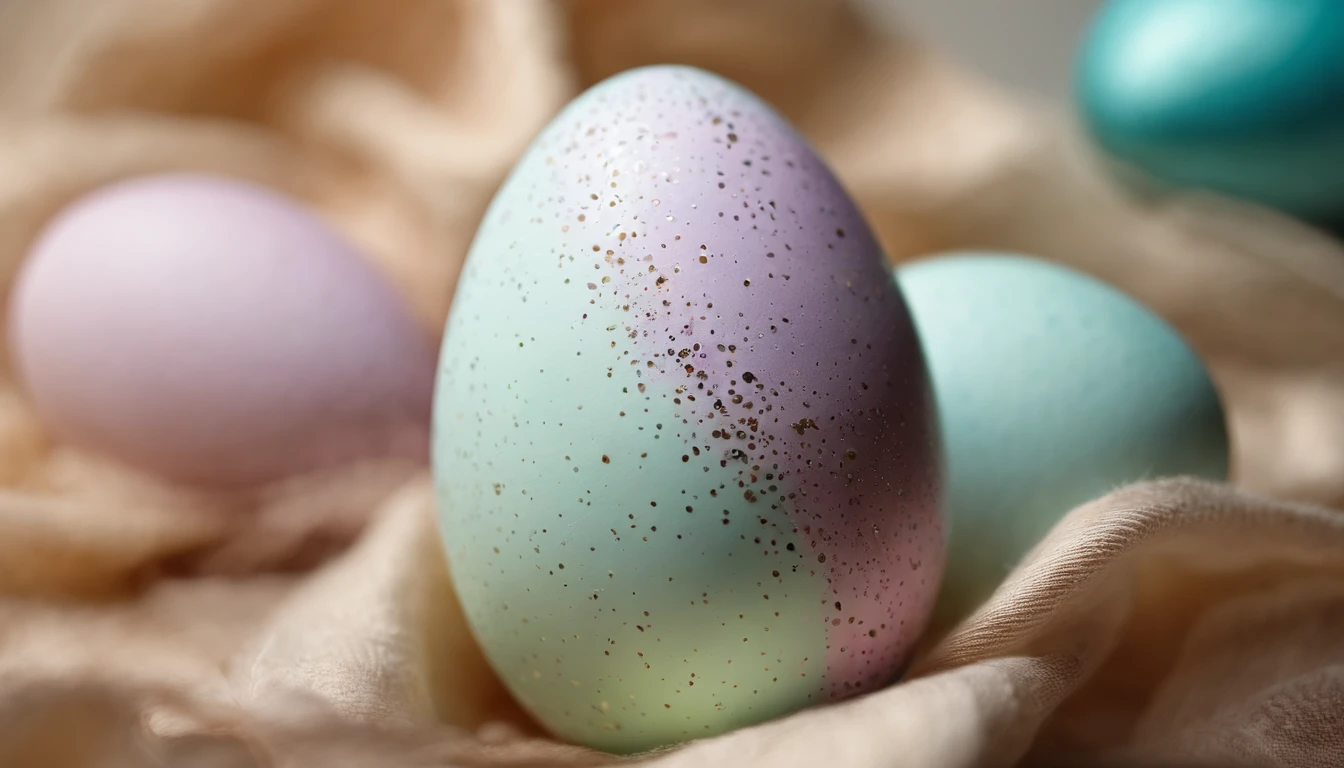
0 0 1344 768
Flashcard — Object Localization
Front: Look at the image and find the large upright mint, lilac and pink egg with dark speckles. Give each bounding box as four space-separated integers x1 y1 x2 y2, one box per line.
434 67 945 752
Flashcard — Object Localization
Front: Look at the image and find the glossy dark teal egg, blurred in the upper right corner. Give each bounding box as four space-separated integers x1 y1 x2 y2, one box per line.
1075 0 1344 225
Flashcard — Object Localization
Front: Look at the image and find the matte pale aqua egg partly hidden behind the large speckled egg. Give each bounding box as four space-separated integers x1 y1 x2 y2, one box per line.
896 254 1228 623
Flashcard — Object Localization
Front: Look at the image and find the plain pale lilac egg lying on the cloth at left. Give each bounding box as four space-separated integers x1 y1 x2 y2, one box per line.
8 175 434 487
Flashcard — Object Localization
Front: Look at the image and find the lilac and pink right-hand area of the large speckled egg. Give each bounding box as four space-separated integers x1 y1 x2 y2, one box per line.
534 69 941 695
